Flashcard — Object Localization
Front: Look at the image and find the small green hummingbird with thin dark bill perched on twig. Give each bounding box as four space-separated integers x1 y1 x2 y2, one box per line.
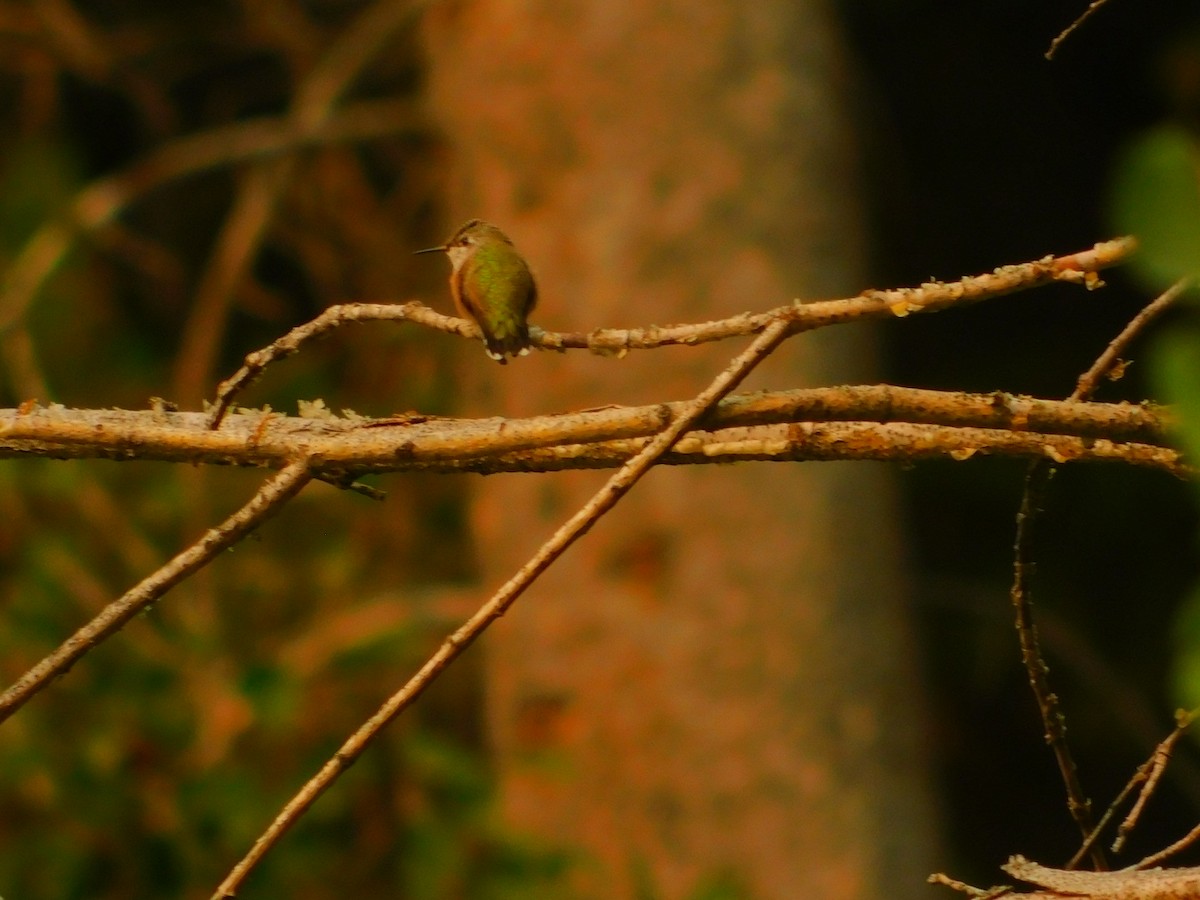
415 218 538 365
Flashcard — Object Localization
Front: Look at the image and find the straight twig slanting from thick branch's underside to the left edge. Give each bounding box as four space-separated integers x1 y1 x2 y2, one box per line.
0 460 312 722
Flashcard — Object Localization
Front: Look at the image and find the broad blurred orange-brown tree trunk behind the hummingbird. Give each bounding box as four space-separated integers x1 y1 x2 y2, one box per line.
426 0 932 899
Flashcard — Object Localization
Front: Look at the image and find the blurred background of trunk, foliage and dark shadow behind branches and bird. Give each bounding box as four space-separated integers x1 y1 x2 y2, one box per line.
0 0 1200 898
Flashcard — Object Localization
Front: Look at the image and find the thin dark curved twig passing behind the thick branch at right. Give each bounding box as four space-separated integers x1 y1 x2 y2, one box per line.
1012 281 1187 869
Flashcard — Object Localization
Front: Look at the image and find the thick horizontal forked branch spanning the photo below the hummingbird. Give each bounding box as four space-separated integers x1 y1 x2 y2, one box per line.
0 384 1187 479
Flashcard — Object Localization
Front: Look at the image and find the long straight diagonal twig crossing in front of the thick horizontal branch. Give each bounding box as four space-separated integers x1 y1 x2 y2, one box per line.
214 317 791 900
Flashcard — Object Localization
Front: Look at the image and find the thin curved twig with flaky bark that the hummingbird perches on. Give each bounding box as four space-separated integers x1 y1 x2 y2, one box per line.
209 238 1134 428
